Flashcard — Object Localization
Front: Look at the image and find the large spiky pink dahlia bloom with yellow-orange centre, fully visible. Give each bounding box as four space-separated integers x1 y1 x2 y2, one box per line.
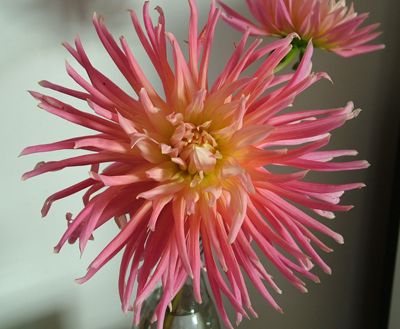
22 0 368 328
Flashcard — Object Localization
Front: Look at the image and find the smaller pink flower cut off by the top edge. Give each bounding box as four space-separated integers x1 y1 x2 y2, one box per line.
218 0 384 57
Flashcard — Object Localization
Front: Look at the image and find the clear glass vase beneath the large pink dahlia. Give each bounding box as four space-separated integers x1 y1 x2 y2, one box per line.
132 276 221 329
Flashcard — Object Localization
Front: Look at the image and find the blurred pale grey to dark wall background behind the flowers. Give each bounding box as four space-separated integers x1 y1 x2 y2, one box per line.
0 0 400 329
